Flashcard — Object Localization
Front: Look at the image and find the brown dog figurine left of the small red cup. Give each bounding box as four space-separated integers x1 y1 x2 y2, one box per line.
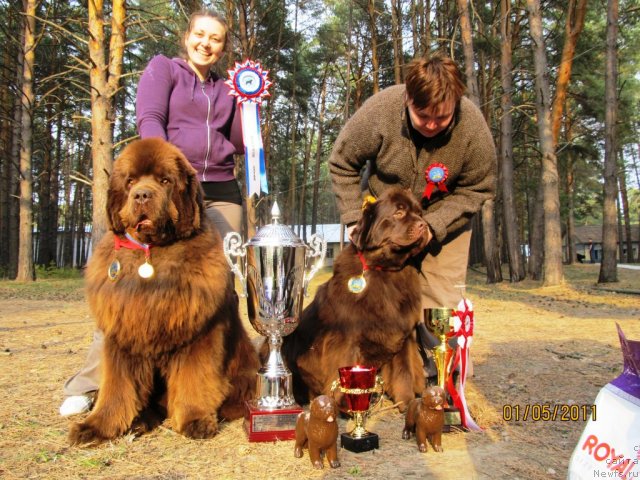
293 395 340 469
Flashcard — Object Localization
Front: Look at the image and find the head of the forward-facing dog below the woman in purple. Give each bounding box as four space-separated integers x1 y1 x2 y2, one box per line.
107 138 204 244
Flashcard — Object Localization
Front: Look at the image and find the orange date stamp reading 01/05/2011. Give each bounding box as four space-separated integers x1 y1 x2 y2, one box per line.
502 403 596 422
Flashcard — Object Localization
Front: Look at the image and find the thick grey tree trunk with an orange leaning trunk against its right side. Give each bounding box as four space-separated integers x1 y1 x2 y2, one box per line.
527 0 563 286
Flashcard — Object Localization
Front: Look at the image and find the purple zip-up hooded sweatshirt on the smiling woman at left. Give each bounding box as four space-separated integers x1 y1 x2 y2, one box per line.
136 55 244 182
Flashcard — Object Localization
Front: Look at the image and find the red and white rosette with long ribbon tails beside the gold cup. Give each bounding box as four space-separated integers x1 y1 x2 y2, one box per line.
447 298 482 431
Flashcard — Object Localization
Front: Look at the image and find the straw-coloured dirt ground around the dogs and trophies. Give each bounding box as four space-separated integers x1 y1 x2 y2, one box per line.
0 265 640 480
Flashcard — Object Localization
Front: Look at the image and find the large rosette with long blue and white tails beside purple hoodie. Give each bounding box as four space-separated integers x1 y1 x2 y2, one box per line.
225 59 271 197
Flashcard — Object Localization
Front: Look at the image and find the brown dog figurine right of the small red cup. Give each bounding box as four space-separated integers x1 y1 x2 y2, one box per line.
402 387 444 453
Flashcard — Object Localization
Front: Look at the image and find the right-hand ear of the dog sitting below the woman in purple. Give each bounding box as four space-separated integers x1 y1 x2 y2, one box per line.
173 153 204 238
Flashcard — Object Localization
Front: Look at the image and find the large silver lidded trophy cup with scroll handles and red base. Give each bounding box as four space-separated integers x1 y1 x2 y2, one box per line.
224 203 327 441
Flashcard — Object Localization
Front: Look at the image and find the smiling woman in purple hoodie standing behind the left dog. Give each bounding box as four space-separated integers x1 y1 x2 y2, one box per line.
60 10 244 416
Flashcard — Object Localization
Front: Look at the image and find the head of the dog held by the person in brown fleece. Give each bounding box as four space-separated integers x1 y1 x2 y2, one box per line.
351 187 427 267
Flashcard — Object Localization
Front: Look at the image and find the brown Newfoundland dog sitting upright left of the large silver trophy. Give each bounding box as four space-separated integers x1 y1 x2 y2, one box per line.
69 138 258 444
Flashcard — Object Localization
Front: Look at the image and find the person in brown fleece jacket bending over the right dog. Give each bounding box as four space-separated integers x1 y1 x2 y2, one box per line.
329 54 497 316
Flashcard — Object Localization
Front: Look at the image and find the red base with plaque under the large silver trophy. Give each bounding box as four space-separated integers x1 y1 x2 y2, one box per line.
244 401 302 442
